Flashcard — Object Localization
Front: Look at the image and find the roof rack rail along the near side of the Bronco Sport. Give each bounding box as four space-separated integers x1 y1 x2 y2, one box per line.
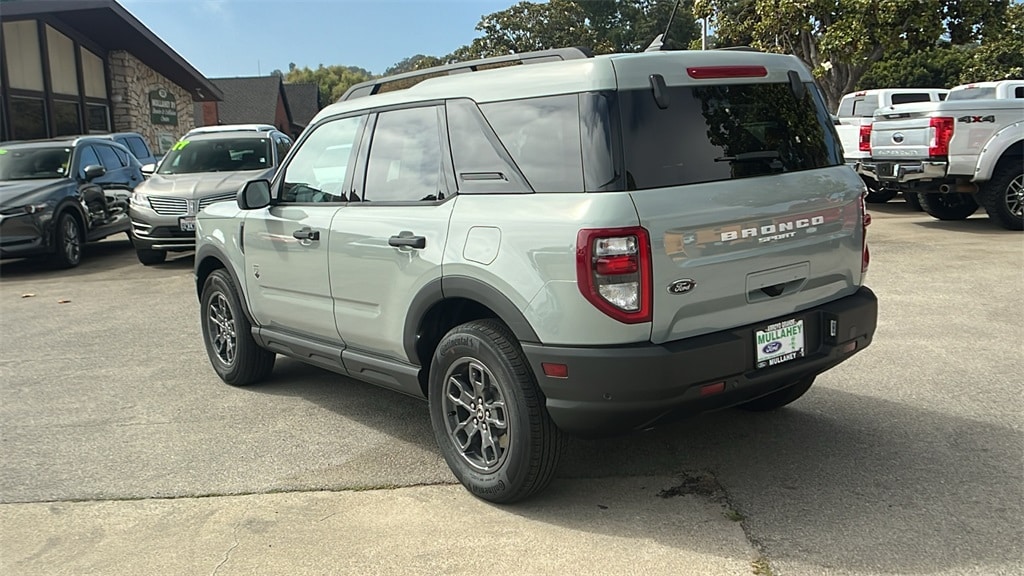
338 46 594 101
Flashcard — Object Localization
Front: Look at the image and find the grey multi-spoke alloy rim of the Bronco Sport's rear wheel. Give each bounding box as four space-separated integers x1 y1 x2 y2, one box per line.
442 358 511 472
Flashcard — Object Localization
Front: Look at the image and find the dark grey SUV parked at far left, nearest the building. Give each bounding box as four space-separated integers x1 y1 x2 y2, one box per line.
0 136 143 268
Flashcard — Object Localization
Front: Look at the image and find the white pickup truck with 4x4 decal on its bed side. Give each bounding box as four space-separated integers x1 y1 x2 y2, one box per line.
858 80 1024 230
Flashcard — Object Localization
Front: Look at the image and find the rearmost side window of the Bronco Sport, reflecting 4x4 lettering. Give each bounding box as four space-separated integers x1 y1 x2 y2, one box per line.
480 94 584 192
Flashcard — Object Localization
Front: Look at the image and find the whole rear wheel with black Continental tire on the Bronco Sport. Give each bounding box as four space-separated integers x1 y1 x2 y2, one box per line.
428 320 563 503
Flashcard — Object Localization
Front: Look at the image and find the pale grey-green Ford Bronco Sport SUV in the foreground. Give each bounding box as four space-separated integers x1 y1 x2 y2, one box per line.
196 50 877 502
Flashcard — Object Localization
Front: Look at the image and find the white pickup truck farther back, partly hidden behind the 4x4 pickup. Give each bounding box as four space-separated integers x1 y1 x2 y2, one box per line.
836 88 949 203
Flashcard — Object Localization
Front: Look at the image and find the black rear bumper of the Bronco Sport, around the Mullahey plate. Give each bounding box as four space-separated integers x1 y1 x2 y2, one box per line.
522 287 878 436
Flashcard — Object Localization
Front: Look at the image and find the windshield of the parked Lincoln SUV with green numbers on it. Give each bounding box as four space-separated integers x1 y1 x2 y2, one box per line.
157 137 273 174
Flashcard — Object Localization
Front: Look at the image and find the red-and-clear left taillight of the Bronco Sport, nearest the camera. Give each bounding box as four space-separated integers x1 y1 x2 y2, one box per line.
577 227 652 324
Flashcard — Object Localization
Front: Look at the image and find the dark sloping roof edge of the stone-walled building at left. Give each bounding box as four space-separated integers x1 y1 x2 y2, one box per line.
0 0 221 101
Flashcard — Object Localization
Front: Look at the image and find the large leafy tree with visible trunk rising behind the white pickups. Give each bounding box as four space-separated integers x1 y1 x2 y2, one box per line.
694 0 1009 110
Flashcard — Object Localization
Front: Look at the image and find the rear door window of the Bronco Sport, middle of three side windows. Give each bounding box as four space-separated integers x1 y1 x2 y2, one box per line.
361 107 445 202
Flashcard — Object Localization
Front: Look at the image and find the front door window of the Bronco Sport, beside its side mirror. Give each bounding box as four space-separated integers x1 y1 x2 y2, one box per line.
281 116 366 203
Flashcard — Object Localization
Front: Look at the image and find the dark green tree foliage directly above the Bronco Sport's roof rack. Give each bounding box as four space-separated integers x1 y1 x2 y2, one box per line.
444 0 698 63
